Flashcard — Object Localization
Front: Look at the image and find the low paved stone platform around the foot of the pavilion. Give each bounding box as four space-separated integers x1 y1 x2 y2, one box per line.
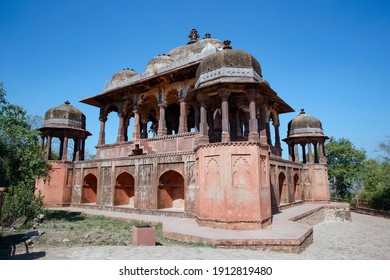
51 203 351 253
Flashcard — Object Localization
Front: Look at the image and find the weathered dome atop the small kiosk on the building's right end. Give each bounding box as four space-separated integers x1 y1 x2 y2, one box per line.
288 109 324 137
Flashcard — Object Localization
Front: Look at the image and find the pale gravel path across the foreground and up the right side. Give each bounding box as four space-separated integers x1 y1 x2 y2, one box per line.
24 213 390 260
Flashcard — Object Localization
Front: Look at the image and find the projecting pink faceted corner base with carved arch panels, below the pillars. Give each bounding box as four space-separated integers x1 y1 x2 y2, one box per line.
195 142 271 230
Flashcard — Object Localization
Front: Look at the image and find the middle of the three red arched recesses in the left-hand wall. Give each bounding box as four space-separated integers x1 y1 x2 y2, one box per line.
114 172 134 207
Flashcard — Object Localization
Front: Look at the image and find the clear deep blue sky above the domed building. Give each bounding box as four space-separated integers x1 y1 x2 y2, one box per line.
0 0 390 157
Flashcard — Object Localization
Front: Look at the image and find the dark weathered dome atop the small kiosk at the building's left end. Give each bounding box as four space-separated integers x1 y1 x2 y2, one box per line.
42 101 85 130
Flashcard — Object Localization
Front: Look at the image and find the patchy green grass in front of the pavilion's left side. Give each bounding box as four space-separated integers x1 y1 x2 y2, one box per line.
0 210 210 247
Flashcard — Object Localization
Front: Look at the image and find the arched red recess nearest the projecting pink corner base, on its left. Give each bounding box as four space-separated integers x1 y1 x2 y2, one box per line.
157 170 184 209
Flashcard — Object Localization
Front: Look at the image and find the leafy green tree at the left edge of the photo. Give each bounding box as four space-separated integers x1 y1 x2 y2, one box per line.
0 83 50 224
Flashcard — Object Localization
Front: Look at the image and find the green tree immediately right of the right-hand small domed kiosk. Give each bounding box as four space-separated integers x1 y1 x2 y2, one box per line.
325 137 366 199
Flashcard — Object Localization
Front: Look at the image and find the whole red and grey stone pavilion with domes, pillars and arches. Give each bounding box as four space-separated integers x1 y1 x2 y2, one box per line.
36 29 330 233
